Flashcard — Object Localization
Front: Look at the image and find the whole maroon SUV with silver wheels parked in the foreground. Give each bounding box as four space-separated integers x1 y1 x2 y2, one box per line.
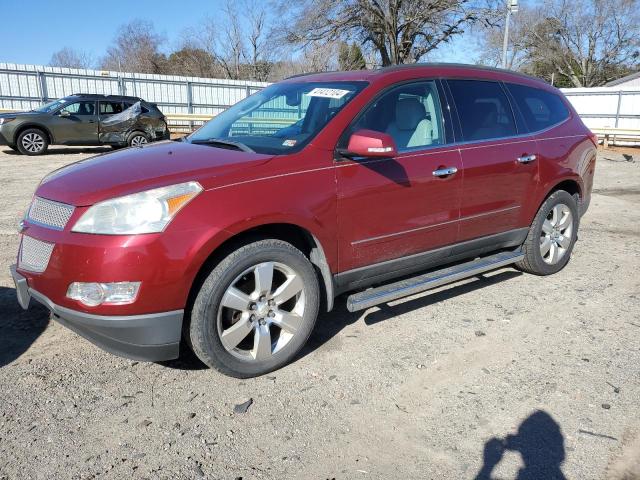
12 65 596 377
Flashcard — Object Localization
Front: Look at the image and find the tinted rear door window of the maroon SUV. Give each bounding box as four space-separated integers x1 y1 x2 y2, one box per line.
448 80 516 141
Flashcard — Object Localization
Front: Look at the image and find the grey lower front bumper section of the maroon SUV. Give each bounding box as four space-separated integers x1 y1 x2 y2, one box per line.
11 265 184 362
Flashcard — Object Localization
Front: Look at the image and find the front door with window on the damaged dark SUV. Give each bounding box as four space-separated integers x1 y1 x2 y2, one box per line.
51 101 98 145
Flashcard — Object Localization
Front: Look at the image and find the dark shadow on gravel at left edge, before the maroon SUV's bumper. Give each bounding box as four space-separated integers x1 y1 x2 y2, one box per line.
0 287 49 368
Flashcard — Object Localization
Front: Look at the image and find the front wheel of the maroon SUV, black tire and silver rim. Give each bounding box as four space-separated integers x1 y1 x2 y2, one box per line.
188 239 320 378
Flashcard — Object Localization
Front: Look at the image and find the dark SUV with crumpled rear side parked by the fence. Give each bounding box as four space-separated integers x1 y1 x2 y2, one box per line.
0 94 169 155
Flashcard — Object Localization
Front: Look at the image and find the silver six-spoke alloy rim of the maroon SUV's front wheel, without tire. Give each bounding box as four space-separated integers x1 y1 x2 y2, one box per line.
217 262 305 362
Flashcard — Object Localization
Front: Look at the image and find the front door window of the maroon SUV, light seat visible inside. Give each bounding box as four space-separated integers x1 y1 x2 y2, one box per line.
343 81 445 150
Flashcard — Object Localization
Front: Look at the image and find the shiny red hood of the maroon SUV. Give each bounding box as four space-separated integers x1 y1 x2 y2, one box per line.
36 141 273 206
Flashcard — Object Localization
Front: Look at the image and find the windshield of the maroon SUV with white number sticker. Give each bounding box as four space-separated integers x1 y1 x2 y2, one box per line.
187 82 367 154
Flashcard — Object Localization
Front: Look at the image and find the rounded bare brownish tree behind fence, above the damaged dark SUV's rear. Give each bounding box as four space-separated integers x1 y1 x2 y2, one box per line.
102 19 166 73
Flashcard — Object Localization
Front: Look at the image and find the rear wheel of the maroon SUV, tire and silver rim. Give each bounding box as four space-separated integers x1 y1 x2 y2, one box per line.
515 190 580 275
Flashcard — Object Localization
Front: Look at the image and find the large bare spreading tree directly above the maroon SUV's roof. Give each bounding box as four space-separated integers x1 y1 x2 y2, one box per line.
280 0 488 66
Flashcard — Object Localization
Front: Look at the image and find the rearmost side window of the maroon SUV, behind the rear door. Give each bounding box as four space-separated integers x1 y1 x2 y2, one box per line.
507 84 569 132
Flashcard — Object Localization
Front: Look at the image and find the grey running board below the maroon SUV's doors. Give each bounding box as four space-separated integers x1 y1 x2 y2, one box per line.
347 250 524 312
